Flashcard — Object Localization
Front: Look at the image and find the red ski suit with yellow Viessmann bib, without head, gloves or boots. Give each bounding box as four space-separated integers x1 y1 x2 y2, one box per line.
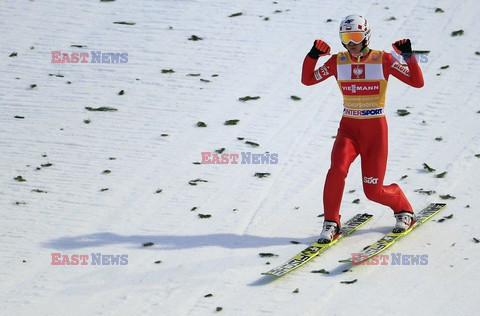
302 50 423 227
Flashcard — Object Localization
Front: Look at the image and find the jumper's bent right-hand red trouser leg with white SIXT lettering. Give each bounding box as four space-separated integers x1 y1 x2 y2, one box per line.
360 117 413 213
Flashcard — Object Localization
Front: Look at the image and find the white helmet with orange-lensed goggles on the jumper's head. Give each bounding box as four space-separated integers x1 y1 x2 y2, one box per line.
340 14 370 47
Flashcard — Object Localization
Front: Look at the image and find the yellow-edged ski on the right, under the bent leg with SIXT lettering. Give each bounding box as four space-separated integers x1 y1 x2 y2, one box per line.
339 203 446 265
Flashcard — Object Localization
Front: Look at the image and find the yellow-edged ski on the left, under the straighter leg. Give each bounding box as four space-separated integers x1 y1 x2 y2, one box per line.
262 213 373 277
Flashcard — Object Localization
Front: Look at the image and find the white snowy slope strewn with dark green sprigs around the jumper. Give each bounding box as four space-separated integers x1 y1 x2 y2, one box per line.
0 0 480 315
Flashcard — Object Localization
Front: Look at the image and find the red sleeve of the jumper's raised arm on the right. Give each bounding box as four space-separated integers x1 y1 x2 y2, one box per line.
383 53 424 88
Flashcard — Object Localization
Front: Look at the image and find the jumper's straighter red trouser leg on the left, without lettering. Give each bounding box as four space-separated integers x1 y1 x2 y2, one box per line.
323 123 360 227
